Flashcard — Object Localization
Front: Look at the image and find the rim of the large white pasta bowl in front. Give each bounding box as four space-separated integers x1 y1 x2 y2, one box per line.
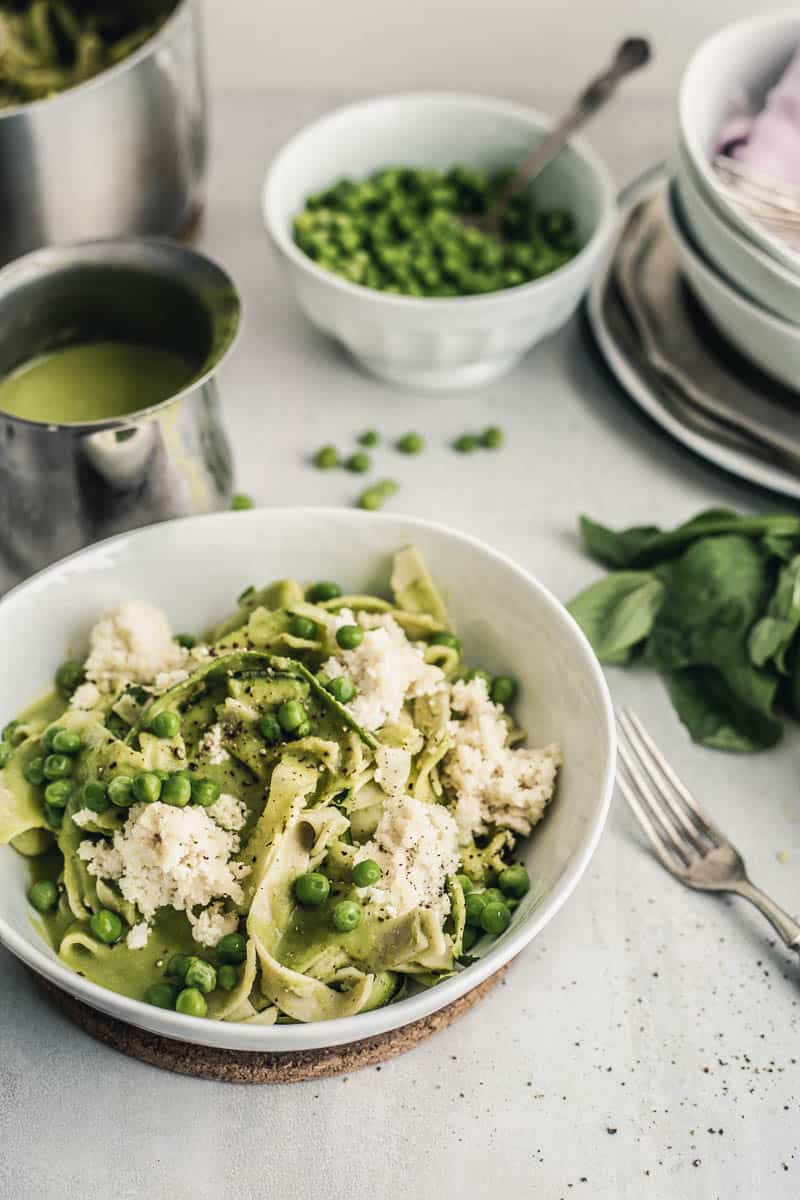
0 506 616 1052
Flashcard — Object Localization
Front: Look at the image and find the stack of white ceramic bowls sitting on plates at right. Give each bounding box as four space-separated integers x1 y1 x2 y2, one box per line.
666 10 800 391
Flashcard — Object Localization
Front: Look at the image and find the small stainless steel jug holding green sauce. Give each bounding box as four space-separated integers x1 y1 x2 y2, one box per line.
0 239 240 581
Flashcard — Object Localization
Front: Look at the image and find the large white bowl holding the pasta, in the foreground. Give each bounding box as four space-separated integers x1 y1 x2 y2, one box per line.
0 509 614 1051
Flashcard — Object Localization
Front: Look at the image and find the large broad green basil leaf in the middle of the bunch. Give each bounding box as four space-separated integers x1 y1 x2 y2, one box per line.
646 534 771 671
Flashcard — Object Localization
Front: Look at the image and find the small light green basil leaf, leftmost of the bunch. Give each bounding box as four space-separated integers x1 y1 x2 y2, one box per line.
567 571 664 665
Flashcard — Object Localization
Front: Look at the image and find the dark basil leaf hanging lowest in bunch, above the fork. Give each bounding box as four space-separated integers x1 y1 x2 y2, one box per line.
668 667 783 754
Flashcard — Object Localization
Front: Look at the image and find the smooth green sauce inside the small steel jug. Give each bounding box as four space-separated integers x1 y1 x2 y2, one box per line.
0 342 196 425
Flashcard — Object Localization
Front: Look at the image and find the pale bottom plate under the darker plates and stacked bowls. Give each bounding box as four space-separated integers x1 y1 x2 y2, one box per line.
587 164 800 500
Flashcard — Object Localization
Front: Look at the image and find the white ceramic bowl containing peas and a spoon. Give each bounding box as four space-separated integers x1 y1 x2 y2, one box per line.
263 94 614 390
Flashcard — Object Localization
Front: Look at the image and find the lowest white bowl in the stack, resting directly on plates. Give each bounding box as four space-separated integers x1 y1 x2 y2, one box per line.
664 187 800 391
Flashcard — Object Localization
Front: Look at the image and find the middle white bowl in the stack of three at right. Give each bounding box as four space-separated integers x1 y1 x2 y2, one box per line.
675 145 800 324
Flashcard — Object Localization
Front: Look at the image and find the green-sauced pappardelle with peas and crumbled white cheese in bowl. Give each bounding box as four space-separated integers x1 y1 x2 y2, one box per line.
0 547 560 1024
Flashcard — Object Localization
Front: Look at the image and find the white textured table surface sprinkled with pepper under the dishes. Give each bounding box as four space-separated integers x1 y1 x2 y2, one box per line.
0 96 800 1200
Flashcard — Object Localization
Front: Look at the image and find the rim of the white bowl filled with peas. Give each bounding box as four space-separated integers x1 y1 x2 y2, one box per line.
261 91 616 313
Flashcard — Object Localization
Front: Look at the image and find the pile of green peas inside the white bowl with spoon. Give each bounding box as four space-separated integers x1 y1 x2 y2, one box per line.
293 166 579 296
